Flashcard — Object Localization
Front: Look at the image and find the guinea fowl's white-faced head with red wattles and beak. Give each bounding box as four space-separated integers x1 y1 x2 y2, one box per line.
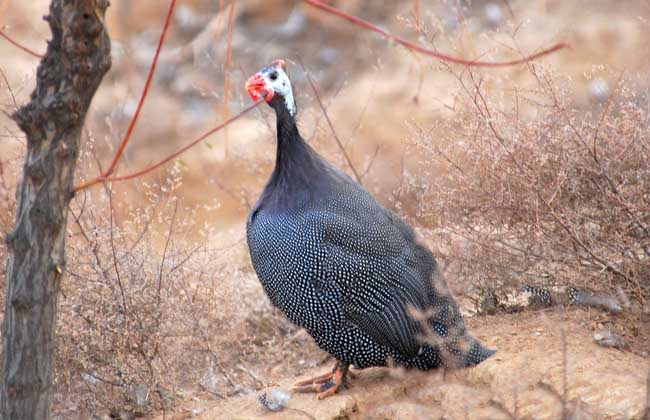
246 59 296 117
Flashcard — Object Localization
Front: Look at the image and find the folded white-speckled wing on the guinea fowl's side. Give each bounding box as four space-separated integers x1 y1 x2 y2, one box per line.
314 203 435 357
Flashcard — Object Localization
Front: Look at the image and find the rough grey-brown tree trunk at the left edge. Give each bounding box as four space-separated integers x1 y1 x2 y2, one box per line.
0 0 111 420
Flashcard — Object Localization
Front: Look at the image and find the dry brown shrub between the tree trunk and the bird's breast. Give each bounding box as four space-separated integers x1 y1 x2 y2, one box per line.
45 167 298 417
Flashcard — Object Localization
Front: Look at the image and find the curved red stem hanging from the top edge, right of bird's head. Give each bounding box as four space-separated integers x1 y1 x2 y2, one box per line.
303 0 568 67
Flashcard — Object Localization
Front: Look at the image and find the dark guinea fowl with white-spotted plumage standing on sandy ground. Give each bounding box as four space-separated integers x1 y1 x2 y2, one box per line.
246 60 494 399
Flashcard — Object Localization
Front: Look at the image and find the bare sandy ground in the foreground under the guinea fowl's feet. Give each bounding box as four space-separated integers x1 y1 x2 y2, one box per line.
156 311 650 420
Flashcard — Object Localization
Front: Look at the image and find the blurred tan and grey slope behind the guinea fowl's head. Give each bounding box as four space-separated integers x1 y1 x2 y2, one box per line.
0 0 650 235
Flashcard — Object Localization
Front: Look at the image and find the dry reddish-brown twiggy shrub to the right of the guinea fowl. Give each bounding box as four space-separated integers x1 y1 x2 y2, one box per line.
411 65 650 305
